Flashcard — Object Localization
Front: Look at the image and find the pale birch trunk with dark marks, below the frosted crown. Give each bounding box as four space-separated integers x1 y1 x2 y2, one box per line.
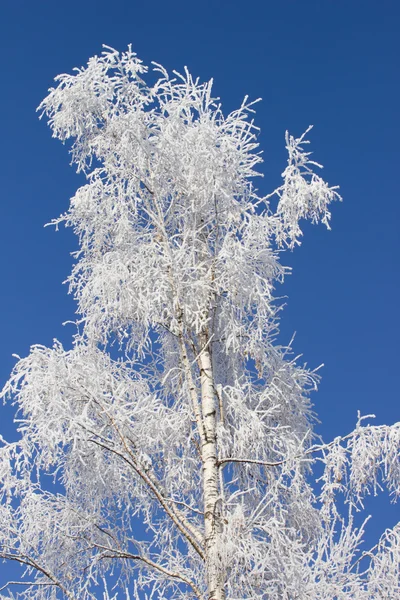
199 340 225 600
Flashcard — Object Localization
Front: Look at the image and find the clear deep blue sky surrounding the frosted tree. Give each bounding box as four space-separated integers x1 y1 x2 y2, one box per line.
0 0 400 570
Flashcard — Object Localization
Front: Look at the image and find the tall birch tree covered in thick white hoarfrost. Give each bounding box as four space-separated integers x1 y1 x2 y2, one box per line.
0 48 400 600
